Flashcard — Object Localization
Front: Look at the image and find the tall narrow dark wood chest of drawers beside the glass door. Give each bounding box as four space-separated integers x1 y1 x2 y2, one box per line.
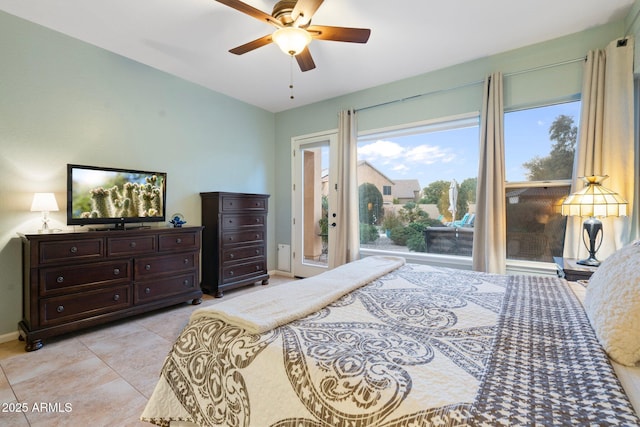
200 192 269 298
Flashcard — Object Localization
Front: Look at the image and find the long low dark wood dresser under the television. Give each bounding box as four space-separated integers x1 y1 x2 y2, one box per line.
18 227 202 351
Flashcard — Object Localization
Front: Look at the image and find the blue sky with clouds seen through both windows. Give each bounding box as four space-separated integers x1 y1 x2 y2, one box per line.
358 102 580 188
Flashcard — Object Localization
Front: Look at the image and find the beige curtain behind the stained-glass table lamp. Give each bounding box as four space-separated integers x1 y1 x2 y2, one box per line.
564 38 638 260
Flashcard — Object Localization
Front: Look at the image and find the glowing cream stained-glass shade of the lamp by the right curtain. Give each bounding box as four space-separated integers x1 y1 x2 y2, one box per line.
562 175 627 217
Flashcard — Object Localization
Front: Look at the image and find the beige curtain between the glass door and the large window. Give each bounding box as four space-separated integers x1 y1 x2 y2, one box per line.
329 110 360 268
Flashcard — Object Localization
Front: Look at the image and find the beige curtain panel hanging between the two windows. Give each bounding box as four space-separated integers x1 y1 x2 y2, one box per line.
473 73 507 274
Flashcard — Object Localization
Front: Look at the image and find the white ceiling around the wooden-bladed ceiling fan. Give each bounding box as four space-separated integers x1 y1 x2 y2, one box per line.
0 0 634 112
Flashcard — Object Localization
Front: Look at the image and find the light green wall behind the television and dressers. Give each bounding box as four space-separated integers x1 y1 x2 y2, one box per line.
0 12 275 336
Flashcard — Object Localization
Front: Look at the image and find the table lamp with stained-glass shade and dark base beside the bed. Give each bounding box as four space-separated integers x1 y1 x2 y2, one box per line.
562 175 627 267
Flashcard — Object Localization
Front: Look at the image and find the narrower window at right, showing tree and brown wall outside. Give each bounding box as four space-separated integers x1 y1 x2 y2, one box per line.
504 101 580 262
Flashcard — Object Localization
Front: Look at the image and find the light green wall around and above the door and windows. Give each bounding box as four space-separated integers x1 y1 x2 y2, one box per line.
275 22 624 254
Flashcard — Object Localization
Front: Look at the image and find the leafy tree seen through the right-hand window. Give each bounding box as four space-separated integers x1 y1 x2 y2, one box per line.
522 114 578 181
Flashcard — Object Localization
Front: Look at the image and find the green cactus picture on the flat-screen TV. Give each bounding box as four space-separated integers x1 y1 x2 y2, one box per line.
72 169 164 219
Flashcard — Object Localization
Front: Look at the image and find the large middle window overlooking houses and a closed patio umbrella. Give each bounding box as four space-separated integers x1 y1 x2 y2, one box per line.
358 114 479 256
